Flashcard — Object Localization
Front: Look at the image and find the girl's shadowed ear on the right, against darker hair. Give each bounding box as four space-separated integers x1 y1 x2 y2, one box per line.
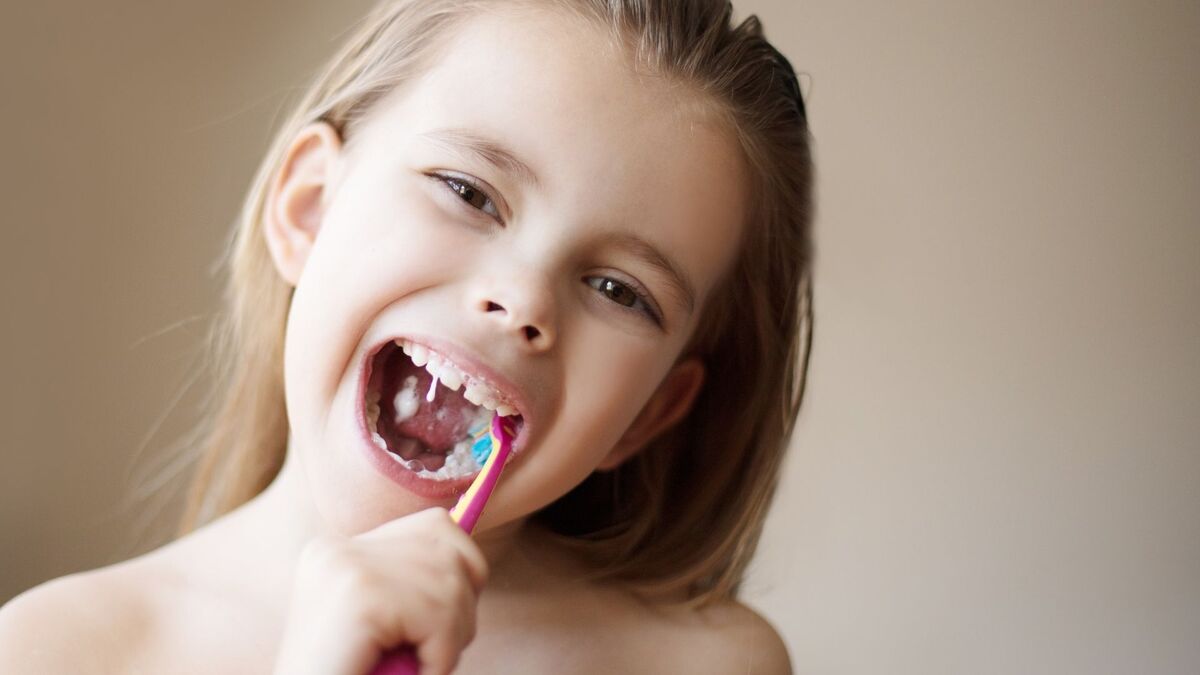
596 357 704 471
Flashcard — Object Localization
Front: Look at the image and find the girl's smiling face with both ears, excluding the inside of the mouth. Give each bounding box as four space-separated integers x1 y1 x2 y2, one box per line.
266 6 746 532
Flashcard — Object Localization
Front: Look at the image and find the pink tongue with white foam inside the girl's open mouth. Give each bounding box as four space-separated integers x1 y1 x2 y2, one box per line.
380 350 478 453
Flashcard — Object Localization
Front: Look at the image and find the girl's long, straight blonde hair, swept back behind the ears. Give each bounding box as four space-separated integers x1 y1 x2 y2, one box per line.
180 0 812 603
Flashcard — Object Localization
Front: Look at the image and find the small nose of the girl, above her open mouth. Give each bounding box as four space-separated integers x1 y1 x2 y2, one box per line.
472 271 557 352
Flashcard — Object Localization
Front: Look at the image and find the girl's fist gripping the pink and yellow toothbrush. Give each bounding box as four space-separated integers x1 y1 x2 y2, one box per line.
275 508 487 675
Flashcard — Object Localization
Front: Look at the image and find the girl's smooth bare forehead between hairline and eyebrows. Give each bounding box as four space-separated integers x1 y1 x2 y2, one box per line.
350 10 746 305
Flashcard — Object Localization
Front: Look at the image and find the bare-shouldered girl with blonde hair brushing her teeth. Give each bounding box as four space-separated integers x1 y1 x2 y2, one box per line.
0 0 812 674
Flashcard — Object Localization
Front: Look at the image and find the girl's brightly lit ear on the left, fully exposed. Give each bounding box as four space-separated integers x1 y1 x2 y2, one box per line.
263 123 342 286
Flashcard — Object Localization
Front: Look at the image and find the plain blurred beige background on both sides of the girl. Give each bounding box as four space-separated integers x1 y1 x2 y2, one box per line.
0 0 1200 674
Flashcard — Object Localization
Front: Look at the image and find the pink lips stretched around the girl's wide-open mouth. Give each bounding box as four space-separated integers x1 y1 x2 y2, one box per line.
354 335 533 501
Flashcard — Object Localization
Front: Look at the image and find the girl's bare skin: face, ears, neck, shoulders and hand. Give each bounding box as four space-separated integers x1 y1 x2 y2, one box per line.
0 6 790 673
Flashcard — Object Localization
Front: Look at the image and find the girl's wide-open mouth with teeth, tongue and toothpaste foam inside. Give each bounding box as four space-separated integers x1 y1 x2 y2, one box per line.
362 339 524 480
